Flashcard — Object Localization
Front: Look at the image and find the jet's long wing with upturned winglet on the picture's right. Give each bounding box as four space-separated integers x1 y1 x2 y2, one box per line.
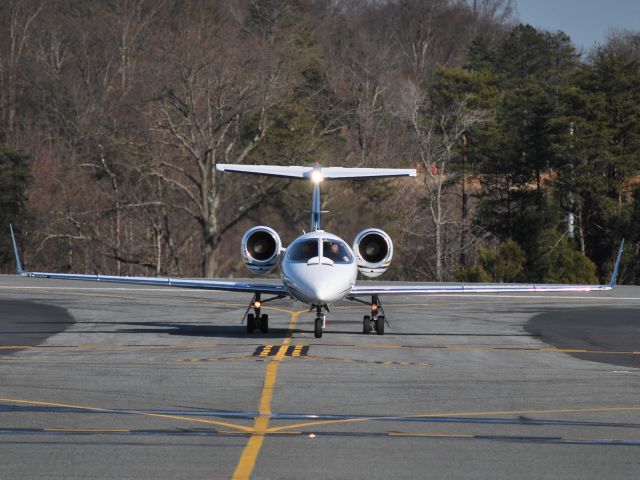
347 240 624 298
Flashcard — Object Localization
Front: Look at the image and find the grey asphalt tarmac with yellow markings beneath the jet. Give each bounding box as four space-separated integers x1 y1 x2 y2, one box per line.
0 276 640 480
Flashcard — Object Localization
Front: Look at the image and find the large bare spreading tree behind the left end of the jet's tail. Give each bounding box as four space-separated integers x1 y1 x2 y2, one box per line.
153 20 298 276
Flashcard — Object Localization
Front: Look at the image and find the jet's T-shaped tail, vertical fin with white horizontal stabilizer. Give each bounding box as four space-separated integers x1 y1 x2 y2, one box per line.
216 163 416 231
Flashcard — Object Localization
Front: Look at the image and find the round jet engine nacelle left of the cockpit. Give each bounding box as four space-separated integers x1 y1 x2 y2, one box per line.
240 226 282 275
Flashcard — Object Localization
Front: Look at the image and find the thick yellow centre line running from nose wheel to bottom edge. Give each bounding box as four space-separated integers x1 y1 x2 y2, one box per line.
231 310 306 480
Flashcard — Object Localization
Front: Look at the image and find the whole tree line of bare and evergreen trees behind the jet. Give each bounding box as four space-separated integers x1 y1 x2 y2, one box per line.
0 0 640 283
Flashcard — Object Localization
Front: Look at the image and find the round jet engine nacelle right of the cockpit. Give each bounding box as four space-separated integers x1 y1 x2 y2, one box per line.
353 228 393 278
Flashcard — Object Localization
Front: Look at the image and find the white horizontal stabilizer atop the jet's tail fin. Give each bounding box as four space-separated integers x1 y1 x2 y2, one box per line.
216 163 416 180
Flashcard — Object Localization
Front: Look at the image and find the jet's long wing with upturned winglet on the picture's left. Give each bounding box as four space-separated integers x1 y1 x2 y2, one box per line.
10 226 289 296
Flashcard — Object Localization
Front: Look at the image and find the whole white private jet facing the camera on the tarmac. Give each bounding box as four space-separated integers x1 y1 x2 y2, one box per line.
11 164 624 338
